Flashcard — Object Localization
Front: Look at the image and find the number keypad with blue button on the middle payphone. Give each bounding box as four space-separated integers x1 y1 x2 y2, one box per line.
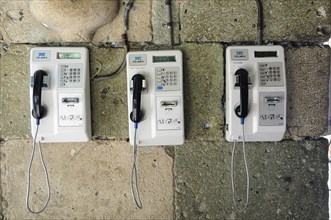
155 67 180 91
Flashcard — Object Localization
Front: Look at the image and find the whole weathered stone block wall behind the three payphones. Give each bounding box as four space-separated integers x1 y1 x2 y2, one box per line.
0 0 331 219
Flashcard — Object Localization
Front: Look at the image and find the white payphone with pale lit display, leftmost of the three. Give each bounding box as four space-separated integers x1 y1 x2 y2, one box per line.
30 47 91 142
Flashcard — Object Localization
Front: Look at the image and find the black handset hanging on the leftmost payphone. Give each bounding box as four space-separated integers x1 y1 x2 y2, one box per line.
32 70 47 120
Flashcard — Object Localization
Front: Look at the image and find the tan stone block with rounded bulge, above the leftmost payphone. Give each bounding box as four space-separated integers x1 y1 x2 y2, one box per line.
0 0 152 44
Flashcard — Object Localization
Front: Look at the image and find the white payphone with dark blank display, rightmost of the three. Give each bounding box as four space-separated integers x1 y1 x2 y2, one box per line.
226 46 287 142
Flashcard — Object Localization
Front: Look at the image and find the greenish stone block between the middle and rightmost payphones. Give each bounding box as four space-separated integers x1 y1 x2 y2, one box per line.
180 44 224 140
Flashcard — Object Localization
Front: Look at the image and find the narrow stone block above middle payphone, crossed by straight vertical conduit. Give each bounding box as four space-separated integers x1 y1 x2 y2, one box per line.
152 0 180 45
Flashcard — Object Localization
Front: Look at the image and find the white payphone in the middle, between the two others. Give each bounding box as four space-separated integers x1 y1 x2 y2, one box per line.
127 50 184 146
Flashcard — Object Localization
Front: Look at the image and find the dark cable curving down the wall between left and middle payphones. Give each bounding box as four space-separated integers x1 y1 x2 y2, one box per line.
91 0 135 81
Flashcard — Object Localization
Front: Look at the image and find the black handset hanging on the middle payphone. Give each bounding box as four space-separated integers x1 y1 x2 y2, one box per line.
130 74 145 123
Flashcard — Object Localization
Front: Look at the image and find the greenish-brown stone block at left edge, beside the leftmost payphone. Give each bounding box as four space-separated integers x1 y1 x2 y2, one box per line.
0 44 32 138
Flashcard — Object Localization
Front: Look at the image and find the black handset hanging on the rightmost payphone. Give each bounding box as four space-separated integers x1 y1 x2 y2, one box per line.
235 69 248 119
